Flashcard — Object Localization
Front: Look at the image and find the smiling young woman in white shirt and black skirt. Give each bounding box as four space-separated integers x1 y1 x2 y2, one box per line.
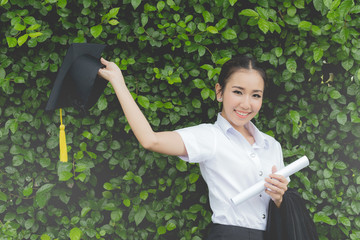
99 57 288 240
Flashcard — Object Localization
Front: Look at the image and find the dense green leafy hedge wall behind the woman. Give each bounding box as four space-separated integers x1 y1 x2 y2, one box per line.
0 0 360 240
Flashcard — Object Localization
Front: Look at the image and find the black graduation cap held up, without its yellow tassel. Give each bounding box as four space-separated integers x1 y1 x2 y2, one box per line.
45 43 107 110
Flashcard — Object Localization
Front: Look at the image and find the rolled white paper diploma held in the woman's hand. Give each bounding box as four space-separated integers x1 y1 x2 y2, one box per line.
231 156 309 205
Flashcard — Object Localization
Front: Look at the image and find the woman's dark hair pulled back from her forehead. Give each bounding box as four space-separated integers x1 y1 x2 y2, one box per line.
218 56 266 93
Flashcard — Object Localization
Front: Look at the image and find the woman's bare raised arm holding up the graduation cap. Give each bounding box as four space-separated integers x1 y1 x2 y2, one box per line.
99 58 187 156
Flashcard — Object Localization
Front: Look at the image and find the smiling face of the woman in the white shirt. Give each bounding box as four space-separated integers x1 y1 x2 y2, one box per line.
215 69 264 132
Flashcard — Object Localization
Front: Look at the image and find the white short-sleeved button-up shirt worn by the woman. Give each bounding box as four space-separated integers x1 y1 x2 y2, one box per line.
177 114 284 230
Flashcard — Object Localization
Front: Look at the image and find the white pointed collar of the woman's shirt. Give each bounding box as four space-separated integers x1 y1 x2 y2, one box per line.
216 113 268 148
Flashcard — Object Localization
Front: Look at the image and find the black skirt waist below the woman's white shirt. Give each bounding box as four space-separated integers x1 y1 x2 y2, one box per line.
206 223 265 240
